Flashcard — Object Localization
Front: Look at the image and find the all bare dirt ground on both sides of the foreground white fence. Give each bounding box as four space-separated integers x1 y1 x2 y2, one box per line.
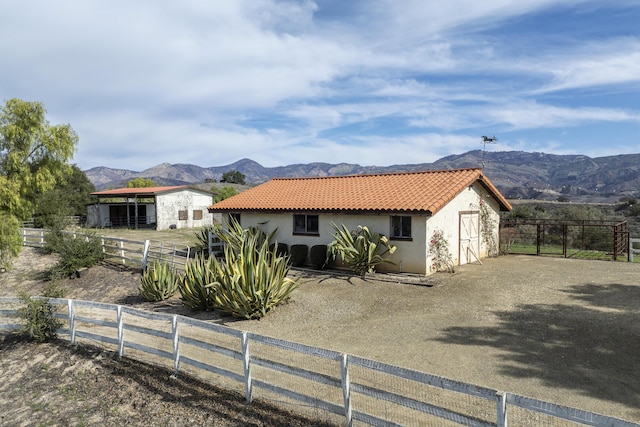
0 248 640 426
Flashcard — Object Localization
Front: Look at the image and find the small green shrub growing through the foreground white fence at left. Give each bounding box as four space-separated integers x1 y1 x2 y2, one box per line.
18 292 62 342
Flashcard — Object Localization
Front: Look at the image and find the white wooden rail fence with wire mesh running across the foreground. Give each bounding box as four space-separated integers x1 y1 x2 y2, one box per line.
0 298 640 427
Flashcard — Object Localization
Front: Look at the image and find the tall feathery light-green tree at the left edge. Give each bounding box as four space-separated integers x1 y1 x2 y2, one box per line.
0 98 78 266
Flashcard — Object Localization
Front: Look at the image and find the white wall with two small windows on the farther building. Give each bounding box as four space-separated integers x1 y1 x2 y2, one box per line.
156 189 213 230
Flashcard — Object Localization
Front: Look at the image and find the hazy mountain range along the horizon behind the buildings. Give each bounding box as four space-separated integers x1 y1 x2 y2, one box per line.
84 150 640 203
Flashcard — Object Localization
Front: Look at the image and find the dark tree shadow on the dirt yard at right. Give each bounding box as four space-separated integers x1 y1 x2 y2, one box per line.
436 284 640 408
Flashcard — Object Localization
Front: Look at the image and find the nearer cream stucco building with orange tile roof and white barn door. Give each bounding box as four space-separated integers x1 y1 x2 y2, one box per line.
209 169 511 274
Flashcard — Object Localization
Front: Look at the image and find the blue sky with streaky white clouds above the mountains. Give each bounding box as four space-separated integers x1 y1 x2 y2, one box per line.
0 0 640 171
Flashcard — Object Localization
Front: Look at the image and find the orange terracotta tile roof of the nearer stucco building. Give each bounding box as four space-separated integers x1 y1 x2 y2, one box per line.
209 169 511 214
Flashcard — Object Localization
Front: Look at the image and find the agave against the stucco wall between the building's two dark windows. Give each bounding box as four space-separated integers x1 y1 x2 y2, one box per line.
327 223 396 276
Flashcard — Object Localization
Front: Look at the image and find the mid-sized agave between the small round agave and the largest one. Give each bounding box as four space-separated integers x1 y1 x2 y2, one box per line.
178 254 217 310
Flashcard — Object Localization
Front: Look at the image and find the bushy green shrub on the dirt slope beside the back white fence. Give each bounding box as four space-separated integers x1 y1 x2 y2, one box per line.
45 231 104 280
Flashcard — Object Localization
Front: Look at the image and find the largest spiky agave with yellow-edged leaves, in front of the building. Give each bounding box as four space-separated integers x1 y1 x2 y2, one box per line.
208 234 298 319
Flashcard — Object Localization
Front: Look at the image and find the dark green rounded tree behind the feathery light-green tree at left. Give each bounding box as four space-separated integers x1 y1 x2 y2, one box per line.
34 165 96 228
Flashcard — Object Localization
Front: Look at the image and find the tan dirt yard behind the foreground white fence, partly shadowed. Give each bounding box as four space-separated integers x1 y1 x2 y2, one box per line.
0 248 640 425
